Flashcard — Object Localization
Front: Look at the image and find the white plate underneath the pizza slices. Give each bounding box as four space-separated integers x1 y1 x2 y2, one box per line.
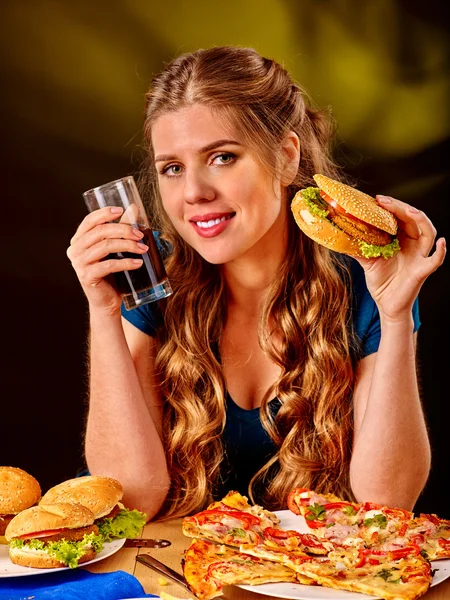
238 510 450 600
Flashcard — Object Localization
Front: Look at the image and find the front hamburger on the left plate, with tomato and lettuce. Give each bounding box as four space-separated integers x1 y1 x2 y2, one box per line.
5 502 103 569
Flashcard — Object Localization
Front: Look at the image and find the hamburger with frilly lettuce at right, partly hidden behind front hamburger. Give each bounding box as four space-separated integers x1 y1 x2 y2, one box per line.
39 475 146 542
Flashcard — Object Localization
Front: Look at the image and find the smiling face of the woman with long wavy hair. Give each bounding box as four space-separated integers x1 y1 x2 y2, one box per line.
152 105 286 264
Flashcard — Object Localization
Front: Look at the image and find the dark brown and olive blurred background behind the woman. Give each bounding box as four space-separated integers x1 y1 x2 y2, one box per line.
0 0 450 518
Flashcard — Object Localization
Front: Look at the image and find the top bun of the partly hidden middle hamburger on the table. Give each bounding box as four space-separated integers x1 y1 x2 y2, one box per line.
39 475 123 519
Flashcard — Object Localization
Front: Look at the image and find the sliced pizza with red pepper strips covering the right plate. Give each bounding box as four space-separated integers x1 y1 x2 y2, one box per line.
182 488 450 600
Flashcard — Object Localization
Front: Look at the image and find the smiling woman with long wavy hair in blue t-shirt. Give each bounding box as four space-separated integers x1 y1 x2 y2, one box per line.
68 47 445 518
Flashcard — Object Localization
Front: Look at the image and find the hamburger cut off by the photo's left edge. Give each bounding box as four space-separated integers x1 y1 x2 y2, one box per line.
0 467 41 544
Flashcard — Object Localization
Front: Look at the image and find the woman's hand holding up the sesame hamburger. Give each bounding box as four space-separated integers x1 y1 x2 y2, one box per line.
356 196 446 321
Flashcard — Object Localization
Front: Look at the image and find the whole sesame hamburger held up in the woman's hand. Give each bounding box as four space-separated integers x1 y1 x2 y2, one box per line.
291 175 400 259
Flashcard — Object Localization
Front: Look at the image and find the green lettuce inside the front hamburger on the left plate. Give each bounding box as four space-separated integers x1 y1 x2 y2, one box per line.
9 532 103 569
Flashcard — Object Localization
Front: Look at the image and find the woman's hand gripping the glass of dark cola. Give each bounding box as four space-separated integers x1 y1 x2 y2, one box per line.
67 207 148 315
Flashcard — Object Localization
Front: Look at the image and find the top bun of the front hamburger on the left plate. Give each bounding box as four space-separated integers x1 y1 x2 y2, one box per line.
5 502 94 542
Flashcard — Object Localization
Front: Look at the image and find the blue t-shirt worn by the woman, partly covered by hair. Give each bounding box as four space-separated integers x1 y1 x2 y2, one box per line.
122 259 420 498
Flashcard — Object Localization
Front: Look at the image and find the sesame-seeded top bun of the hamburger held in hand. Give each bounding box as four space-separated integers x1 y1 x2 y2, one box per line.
314 175 397 235
